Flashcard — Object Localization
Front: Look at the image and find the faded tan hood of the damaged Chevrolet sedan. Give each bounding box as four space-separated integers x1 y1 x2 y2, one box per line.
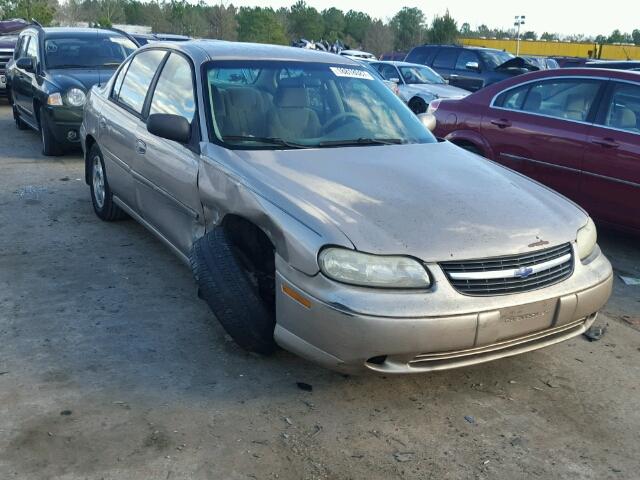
229 142 587 261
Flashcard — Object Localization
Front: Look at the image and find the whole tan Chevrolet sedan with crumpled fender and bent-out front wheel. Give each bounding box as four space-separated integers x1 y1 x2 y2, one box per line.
81 41 612 373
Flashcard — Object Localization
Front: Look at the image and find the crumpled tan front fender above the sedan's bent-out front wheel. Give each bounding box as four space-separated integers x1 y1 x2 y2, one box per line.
198 152 354 275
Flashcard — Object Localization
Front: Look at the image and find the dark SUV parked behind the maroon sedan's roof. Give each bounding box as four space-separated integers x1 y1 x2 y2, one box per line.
404 45 539 92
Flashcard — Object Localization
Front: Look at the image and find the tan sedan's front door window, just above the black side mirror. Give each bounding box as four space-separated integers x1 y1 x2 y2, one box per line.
149 53 196 122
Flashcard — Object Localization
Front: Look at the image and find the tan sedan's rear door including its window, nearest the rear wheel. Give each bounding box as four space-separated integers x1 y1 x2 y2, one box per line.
98 50 167 210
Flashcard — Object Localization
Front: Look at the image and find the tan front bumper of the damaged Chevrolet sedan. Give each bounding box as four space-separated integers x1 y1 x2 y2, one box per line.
275 246 613 373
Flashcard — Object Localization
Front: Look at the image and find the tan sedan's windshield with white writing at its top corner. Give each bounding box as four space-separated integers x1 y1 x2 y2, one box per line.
205 61 436 149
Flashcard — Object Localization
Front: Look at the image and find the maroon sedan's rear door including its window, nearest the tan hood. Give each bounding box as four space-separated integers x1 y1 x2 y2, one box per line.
481 77 604 203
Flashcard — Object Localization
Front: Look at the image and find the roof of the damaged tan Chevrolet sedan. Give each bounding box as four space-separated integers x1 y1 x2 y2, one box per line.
142 40 360 66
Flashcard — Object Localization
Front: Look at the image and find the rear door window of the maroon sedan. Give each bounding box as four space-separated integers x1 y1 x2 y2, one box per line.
496 78 601 122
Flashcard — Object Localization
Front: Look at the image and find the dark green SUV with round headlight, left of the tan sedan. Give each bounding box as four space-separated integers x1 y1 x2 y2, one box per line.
7 25 138 155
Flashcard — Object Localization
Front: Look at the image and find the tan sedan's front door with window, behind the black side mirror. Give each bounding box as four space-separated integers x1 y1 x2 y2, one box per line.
133 52 204 255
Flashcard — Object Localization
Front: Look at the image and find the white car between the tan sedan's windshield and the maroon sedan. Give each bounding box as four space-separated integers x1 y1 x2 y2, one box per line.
371 62 471 114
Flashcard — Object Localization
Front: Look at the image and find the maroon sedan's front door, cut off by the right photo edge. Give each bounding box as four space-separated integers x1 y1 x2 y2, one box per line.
580 81 640 232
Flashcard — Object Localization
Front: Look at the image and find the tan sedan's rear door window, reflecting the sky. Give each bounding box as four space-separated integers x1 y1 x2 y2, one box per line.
118 50 166 113
